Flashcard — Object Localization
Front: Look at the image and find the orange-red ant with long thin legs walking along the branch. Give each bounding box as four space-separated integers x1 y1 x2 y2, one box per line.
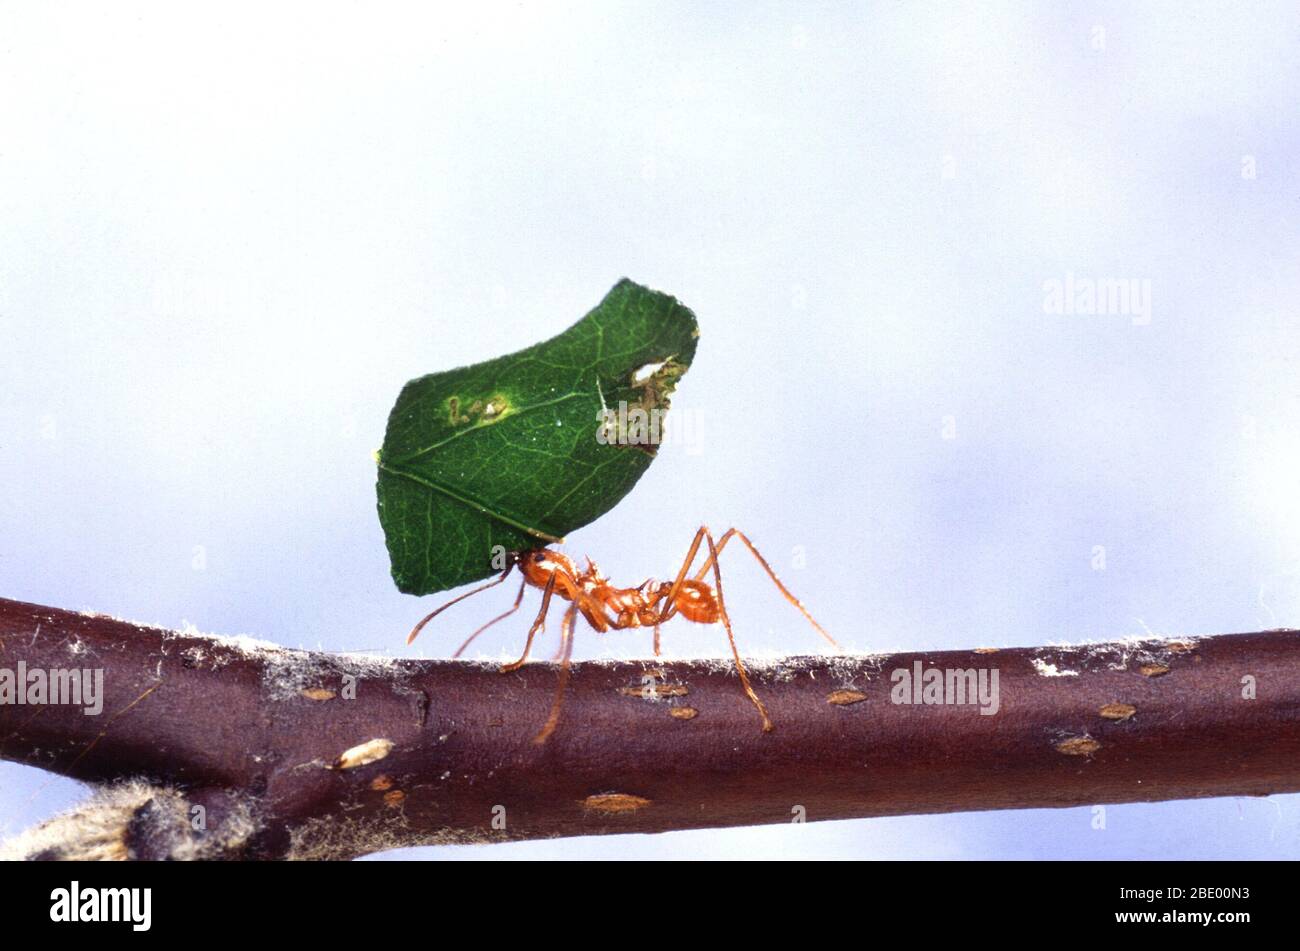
407 525 840 744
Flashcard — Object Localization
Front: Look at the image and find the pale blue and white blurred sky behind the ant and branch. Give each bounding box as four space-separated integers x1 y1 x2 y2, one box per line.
0 3 1300 857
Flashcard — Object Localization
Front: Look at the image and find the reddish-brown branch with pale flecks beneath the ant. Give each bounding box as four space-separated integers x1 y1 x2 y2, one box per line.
0 600 1300 859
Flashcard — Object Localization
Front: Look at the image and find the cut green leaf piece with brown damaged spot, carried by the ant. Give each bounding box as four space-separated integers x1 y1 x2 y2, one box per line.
377 279 699 594
